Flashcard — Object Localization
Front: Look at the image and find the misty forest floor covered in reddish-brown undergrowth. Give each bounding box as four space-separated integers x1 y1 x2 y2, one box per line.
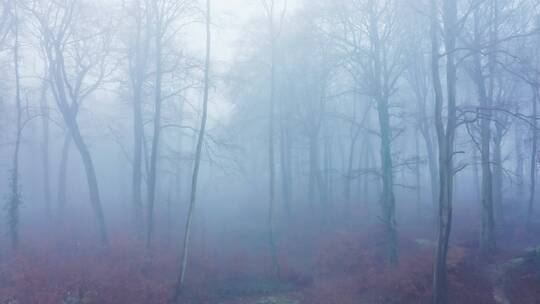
0 203 540 304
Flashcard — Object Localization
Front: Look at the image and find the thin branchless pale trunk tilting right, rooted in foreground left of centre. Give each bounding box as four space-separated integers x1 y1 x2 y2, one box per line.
174 0 212 296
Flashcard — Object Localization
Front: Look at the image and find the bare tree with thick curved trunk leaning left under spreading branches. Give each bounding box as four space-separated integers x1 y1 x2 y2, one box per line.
30 0 110 244
